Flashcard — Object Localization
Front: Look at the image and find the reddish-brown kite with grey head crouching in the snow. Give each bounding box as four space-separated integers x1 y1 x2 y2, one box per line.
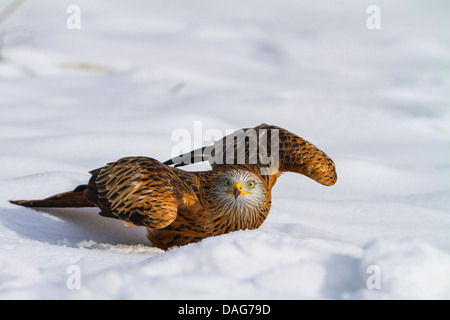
10 124 337 250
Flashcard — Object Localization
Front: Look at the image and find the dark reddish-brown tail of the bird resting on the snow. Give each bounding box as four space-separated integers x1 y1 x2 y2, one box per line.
9 185 96 208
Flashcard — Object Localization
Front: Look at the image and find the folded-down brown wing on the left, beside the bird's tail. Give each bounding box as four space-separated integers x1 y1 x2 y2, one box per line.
85 157 194 229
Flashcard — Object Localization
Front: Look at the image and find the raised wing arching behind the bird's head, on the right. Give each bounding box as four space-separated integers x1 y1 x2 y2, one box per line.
164 124 337 186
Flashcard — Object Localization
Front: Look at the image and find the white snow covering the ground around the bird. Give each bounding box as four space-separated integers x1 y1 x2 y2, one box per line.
0 0 450 299
